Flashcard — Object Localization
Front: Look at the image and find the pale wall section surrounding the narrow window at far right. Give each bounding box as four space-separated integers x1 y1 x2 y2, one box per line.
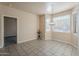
72 4 79 49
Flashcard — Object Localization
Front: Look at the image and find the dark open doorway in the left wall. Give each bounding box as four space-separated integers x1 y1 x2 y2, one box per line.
4 16 17 47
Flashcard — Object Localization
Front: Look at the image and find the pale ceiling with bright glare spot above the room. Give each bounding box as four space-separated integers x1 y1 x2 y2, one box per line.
2 2 77 15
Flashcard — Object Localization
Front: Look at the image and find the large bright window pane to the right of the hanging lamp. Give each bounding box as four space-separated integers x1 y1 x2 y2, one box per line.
52 15 70 32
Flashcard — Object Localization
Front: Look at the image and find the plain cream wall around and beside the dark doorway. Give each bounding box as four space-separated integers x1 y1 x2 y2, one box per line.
0 6 37 46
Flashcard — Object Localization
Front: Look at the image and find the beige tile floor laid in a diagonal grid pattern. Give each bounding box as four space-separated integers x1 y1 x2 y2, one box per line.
0 40 78 56
